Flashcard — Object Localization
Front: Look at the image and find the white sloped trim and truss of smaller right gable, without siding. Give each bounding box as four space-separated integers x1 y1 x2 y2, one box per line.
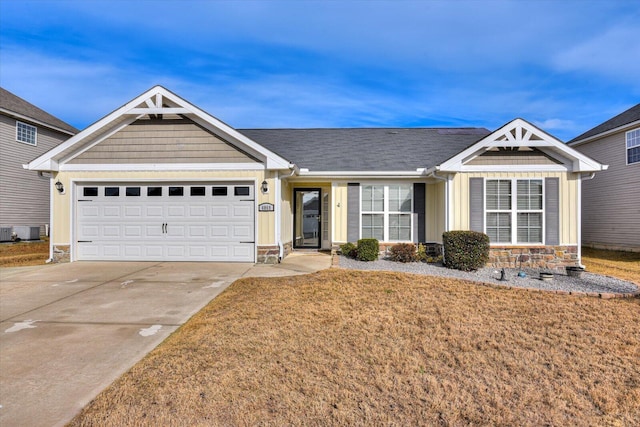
438 119 607 172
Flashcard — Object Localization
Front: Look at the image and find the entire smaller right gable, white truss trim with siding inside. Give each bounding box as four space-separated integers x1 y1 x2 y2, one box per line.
428 119 607 172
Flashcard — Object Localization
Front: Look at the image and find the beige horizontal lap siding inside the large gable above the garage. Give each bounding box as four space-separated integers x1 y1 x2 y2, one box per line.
68 119 258 164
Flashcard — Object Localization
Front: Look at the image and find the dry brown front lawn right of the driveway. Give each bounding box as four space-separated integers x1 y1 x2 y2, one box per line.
71 269 640 426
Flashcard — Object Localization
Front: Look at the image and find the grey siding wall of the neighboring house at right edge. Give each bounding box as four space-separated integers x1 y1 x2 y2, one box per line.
573 131 640 250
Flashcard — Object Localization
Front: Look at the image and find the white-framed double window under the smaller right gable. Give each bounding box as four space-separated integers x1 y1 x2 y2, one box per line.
485 179 544 243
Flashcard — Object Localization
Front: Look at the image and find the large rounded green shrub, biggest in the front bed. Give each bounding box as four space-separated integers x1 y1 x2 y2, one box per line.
442 230 489 271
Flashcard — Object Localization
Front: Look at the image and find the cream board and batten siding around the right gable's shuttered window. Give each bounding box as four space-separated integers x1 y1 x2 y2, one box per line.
450 172 584 245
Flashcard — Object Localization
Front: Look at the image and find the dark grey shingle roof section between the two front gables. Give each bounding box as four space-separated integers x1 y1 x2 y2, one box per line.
238 128 490 172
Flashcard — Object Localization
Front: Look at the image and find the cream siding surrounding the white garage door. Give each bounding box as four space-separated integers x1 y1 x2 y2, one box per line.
51 171 277 246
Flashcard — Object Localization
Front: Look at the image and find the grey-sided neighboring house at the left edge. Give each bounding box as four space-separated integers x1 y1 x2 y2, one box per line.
0 88 78 240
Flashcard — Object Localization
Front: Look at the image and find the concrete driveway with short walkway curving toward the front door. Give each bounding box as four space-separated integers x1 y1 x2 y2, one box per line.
0 254 331 427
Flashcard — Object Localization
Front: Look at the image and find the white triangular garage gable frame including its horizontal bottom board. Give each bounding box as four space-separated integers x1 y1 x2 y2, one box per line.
25 86 293 171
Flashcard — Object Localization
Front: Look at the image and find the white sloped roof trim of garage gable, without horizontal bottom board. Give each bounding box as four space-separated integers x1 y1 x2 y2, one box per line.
28 86 289 171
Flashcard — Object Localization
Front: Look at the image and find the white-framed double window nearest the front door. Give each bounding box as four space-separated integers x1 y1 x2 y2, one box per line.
360 184 413 242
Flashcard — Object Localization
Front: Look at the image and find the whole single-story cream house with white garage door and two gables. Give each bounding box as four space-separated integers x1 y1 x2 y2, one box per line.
28 86 604 268
